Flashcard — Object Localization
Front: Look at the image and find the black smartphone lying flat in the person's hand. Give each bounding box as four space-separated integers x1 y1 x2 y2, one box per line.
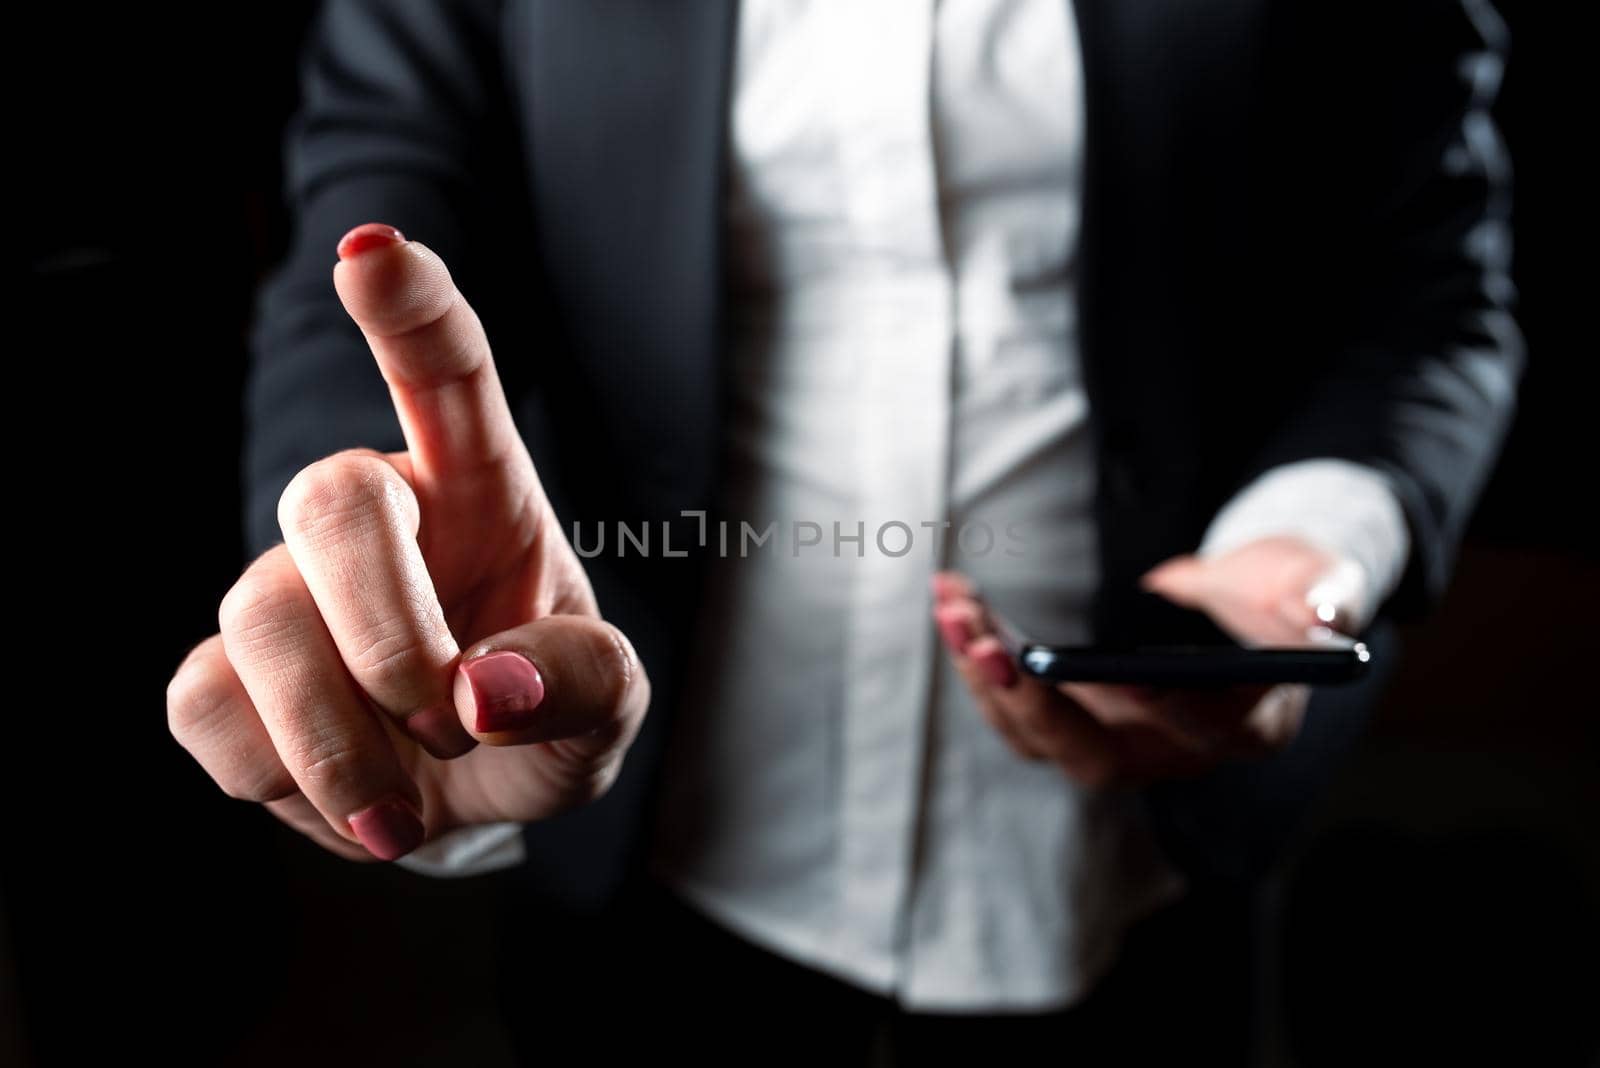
986 590 1371 686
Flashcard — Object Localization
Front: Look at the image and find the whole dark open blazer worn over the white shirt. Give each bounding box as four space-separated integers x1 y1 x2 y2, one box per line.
246 0 1522 905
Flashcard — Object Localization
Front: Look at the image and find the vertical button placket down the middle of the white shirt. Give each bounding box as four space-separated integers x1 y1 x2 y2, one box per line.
829 0 952 984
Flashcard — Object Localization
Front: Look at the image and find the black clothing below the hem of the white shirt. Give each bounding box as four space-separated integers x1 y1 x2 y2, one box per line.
498 883 1261 1068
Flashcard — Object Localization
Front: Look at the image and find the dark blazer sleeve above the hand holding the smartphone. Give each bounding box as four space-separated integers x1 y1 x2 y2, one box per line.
1240 0 1525 617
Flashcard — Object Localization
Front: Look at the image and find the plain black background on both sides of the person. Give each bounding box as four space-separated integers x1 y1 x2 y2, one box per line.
0 0 1600 1065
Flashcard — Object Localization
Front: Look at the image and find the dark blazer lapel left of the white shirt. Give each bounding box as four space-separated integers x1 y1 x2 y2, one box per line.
507 0 736 513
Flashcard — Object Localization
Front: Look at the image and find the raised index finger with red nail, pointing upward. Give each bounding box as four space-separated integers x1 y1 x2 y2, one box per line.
333 222 538 499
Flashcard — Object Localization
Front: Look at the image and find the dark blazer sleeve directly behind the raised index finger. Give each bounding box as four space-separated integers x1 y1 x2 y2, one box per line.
243 0 502 553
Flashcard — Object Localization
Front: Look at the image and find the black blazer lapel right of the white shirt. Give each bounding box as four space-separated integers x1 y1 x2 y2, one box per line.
1074 0 1266 444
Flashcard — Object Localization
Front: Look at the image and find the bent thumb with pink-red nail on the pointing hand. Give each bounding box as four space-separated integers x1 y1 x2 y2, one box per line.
454 616 650 771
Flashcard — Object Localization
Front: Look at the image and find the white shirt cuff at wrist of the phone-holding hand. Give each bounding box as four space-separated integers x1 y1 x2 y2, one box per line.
1200 459 1411 617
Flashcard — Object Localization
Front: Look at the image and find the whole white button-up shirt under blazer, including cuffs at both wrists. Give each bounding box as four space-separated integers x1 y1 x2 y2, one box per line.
397 0 1408 1010
